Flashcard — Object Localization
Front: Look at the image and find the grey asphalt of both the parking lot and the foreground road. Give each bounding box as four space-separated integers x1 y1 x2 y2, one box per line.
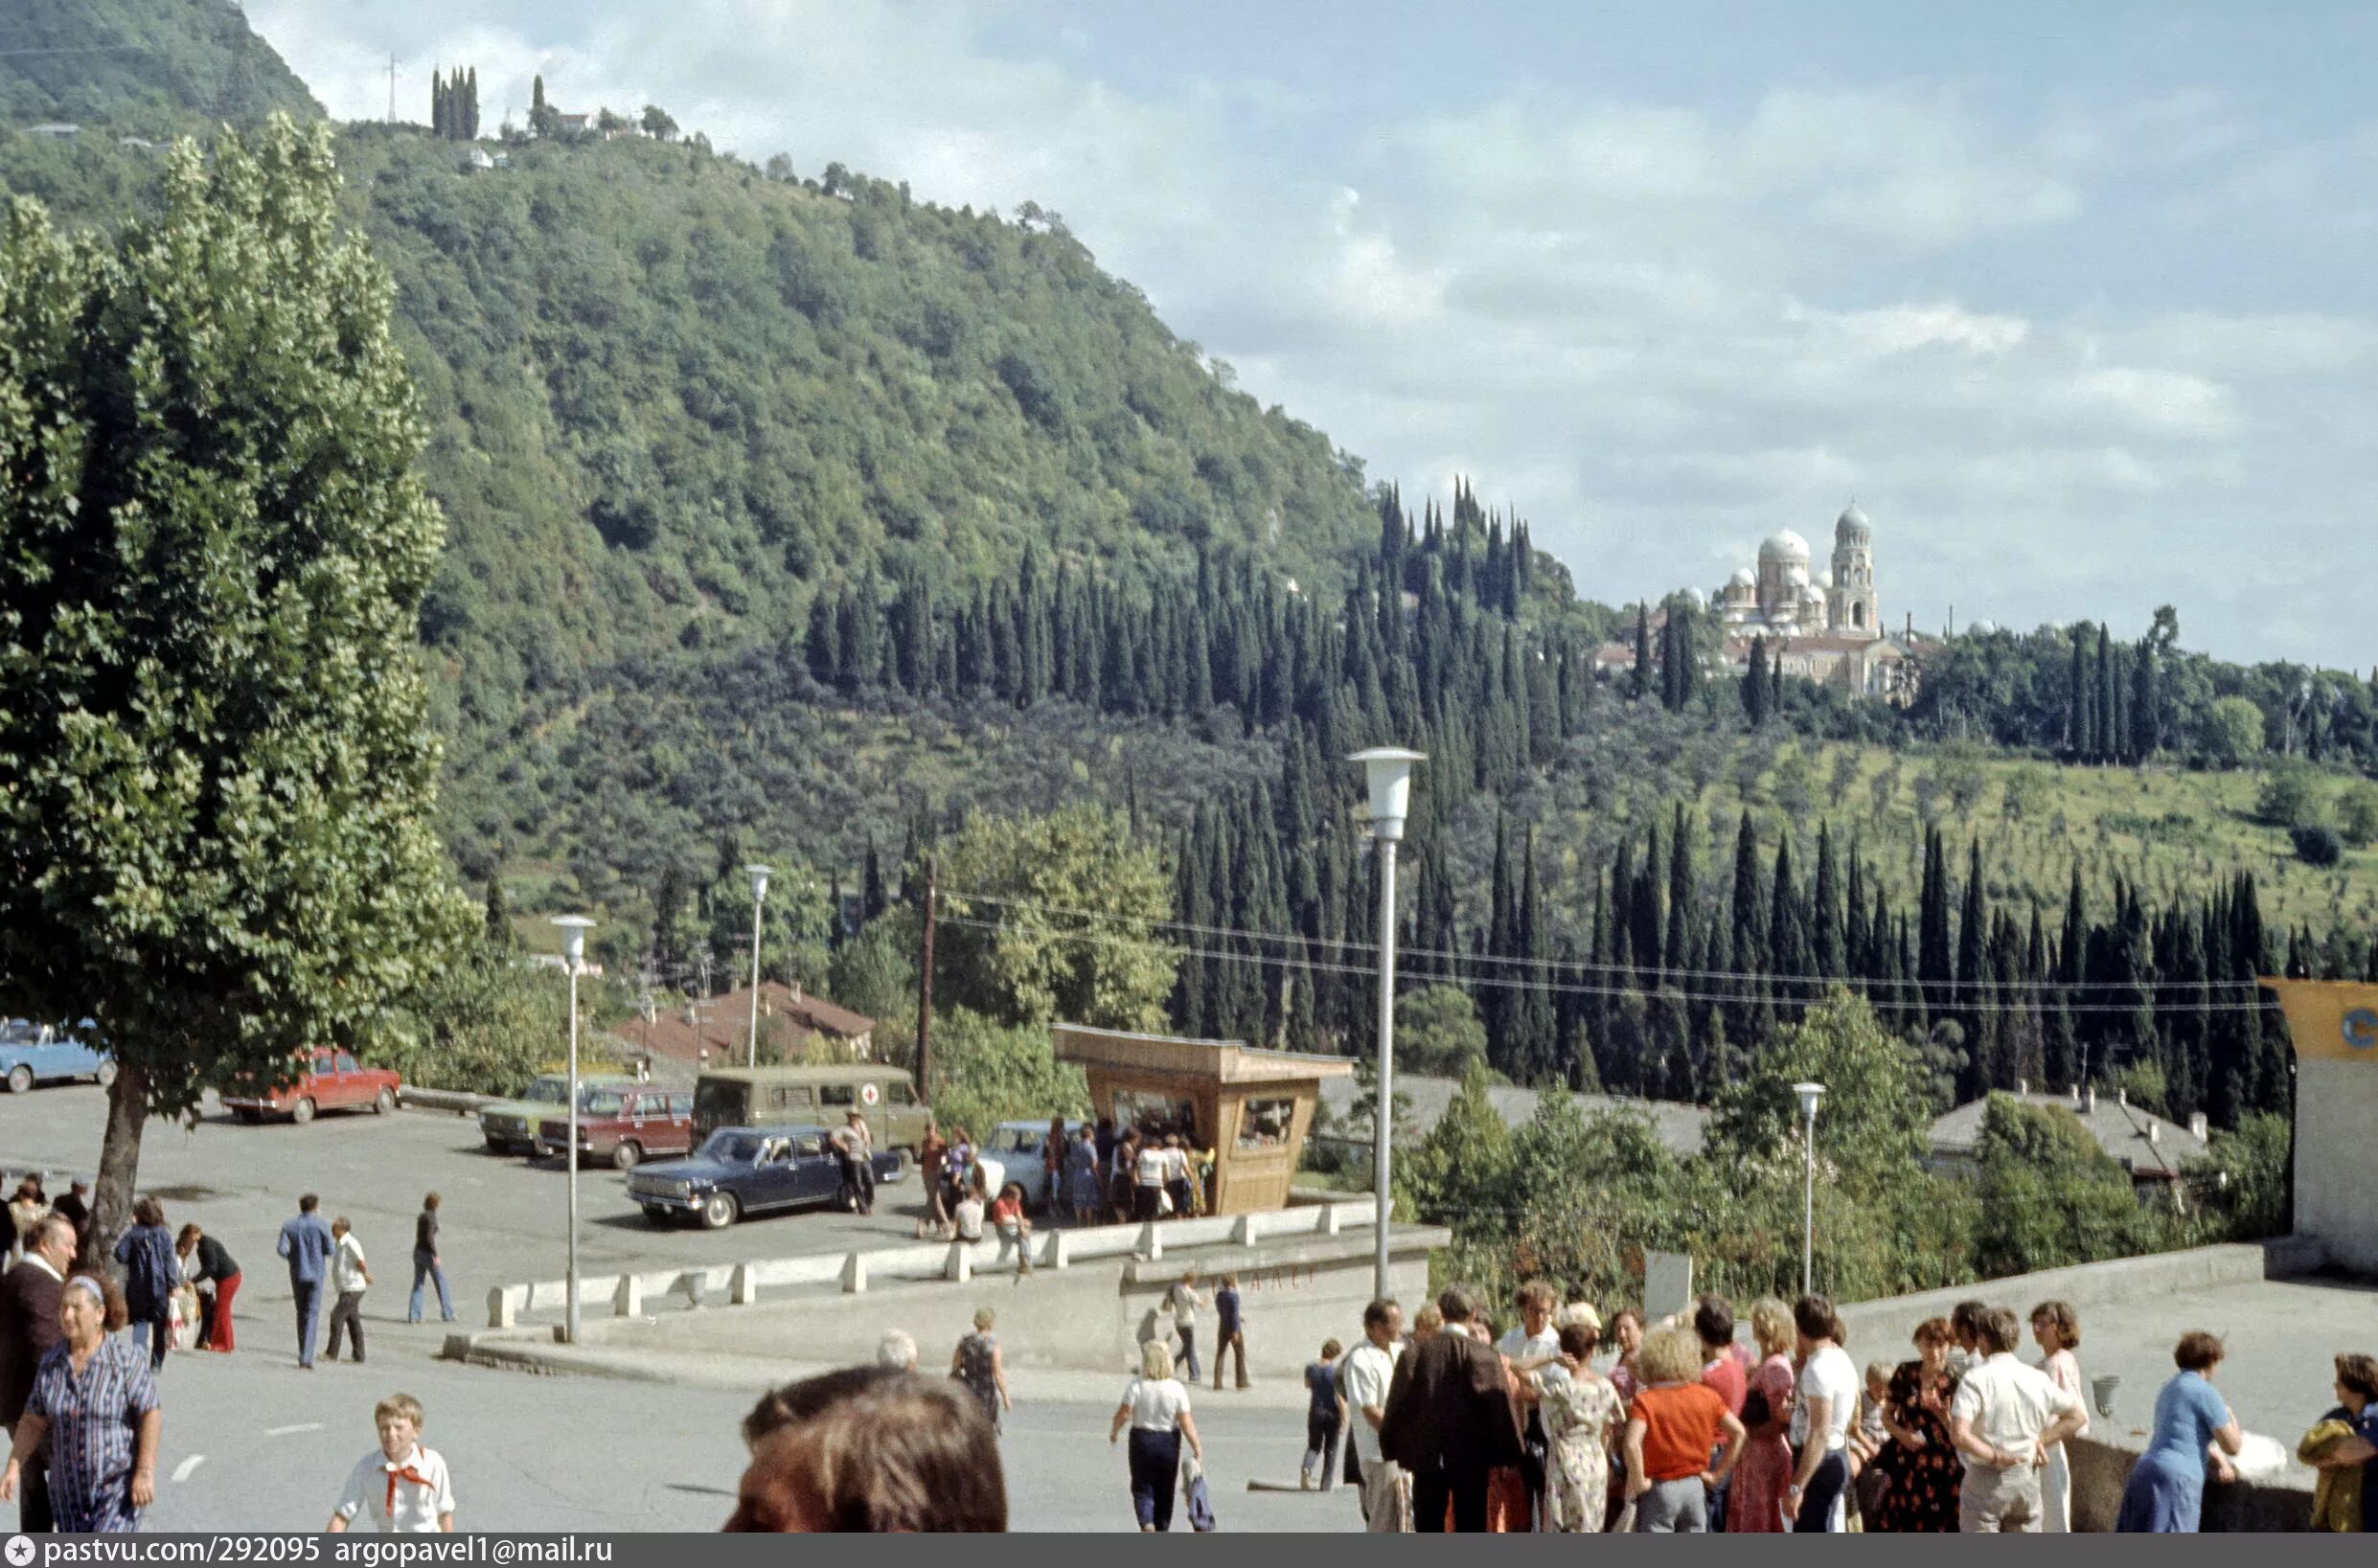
0 1085 1360 1533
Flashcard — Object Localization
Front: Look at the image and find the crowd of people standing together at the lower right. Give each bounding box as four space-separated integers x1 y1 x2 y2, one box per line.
1284 1281 2378 1533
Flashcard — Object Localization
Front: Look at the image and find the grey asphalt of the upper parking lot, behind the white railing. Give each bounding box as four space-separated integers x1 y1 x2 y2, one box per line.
0 1083 923 1335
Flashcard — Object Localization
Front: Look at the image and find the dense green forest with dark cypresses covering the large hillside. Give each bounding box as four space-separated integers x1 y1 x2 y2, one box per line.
0 0 2378 1140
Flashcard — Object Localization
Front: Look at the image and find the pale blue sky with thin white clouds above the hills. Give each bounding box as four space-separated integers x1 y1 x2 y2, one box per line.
247 0 2378 670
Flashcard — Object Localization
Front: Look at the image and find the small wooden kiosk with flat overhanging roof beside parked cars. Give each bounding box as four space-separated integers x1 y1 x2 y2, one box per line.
1054 1024 1353 1214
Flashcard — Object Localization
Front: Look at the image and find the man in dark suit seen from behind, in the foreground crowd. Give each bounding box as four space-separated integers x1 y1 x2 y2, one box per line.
1380 1285 1520 1533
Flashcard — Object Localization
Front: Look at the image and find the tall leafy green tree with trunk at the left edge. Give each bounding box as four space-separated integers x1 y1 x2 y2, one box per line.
0 117 473 1247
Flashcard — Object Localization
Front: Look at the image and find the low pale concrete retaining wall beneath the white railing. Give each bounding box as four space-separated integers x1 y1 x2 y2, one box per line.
583 1226 1449 1378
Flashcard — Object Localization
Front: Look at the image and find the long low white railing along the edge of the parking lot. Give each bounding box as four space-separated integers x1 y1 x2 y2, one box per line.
488 1197 1377 1328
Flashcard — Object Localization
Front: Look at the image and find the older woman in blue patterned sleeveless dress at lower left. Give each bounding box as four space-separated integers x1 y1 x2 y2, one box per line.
0 1273 159 1534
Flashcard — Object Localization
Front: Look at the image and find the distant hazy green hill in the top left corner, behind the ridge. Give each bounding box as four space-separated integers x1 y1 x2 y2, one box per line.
0 0 321 138
